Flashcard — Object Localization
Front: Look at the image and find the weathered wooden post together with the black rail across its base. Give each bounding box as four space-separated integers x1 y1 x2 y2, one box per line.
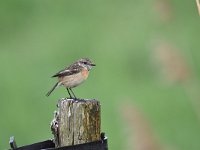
9 98 108 150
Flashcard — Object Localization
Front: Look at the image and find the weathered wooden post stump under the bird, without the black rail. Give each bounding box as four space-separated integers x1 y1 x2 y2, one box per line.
51 99 101 147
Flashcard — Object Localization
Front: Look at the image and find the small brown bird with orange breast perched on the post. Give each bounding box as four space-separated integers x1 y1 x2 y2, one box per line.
46 58 96 99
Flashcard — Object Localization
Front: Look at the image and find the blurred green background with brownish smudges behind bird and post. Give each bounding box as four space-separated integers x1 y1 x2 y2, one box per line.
0 0 200 150
